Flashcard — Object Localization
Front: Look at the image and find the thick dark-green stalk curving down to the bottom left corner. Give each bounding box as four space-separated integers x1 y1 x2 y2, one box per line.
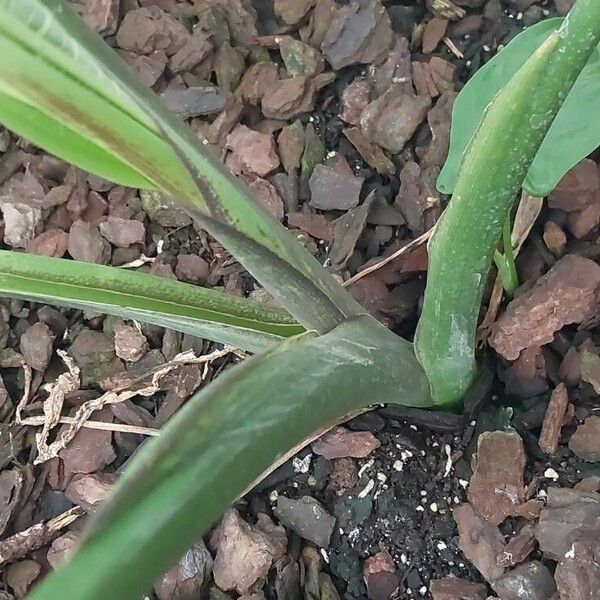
29 317 431 600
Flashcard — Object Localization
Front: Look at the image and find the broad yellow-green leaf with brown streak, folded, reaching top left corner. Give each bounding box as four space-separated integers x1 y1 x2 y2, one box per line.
0 0 364 332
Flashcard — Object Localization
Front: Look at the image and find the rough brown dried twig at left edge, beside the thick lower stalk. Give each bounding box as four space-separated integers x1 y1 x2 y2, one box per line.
0 506 85 566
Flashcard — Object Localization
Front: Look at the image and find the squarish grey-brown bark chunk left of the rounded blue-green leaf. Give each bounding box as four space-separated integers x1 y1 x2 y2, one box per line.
360 84 431 154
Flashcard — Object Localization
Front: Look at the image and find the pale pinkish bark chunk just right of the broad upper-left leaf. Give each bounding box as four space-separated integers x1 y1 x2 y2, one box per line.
225 125 279 177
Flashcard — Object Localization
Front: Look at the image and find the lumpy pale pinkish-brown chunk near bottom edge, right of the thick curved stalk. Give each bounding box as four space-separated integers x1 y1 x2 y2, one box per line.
210 509 287 594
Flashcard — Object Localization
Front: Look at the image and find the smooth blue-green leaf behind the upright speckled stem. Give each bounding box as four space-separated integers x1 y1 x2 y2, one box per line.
437 18 600 198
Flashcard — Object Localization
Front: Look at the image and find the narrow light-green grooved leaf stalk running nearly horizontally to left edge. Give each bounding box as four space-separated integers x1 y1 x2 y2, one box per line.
0 250 303 352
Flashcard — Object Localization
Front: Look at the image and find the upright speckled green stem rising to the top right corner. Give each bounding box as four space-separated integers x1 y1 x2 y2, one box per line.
415 0 600 404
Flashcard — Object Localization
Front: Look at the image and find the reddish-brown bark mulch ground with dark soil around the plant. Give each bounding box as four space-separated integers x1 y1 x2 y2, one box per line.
0 0 600 600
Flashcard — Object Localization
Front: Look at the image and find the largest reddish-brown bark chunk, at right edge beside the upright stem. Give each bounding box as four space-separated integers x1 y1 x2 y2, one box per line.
489 254 600 360
